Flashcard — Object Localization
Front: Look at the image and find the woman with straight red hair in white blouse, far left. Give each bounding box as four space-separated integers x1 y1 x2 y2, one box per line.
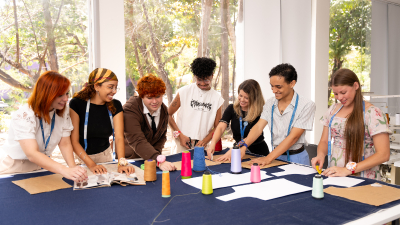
0 71 87 181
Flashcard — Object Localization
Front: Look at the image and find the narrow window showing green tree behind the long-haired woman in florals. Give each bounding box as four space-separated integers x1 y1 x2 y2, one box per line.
328 0 372 105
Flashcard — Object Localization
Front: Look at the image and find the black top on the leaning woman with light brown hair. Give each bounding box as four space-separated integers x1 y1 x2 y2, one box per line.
220 104 264 147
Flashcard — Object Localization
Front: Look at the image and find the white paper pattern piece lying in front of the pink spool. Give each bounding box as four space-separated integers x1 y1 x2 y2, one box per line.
217 178 312 202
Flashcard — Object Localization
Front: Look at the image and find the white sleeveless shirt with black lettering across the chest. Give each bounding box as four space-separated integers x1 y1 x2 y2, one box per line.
176 83 224 140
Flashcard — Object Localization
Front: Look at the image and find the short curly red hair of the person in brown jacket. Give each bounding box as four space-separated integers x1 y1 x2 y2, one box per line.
136 73 167 98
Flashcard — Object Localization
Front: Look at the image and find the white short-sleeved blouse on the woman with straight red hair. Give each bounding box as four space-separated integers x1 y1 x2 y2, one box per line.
1 104 74 159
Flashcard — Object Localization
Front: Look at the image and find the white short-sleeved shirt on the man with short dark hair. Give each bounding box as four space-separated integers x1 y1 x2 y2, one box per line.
260 92 315 150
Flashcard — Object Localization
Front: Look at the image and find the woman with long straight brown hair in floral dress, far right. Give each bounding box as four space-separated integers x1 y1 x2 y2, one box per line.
311 69 391 180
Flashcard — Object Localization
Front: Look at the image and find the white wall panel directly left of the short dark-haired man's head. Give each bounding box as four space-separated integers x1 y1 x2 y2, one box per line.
242 0 281 149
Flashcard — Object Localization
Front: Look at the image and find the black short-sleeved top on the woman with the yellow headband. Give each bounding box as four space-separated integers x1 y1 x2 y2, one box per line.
69 98 123 155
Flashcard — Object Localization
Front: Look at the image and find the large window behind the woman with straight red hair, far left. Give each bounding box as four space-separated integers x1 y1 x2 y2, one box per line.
0 0 89 115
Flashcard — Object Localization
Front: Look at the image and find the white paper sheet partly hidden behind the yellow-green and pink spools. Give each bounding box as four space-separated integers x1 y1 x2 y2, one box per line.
182 171 272 189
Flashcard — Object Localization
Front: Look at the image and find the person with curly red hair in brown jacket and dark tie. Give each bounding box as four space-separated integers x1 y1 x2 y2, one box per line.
124 74 176 171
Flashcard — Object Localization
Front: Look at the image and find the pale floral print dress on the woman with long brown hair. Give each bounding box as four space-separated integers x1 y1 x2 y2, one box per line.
320 104 392 180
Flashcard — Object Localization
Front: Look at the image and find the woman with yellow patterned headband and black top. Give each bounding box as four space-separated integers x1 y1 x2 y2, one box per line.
70 68 134 174
